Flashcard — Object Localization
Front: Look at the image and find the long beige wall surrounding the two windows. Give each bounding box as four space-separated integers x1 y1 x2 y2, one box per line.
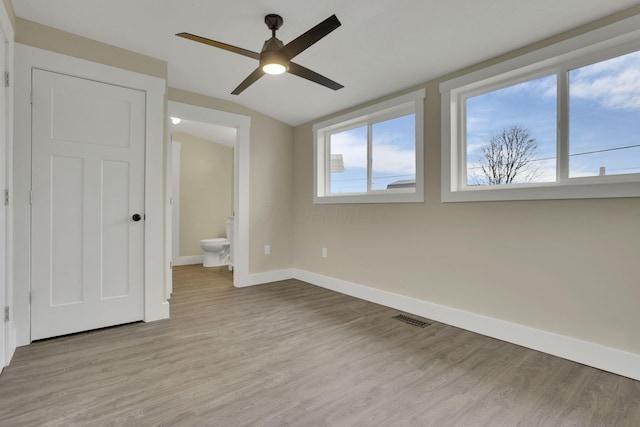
294 8 640 354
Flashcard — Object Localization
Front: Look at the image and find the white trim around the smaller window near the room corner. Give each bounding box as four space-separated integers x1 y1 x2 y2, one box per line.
313 89 426 204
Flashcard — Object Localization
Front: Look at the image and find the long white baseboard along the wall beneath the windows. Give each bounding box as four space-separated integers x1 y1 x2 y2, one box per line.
287 269 640 380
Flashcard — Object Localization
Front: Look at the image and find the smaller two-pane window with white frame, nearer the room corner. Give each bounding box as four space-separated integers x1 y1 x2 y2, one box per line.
313 90 425 203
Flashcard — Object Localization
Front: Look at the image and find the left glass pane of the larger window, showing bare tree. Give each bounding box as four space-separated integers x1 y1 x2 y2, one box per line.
463 74 557 187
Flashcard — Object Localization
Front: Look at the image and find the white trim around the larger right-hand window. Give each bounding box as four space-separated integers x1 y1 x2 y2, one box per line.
440 15 640 202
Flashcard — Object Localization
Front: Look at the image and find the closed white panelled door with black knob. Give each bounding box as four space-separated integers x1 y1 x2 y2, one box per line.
31 69 145 340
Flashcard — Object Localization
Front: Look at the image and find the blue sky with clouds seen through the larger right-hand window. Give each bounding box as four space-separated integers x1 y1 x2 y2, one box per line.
467 52 640 184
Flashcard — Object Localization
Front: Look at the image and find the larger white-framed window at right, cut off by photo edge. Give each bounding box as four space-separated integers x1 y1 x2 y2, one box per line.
440 17 640 201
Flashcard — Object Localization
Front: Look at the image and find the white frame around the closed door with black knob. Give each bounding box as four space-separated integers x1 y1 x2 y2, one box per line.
13 44 169 345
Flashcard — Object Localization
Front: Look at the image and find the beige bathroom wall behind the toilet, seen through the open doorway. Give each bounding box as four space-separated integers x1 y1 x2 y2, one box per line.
173 132 233 256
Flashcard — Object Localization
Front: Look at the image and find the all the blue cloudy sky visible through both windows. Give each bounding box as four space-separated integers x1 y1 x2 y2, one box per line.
331 48 640 193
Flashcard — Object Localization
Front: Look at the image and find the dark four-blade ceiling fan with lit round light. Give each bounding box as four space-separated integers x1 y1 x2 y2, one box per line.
176 13 344 95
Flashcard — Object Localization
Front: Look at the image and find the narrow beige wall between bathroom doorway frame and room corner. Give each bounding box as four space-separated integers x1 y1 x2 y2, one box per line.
168 87 293 273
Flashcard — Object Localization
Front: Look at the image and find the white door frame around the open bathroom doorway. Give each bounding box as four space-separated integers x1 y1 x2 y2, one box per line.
166 101 252 287
